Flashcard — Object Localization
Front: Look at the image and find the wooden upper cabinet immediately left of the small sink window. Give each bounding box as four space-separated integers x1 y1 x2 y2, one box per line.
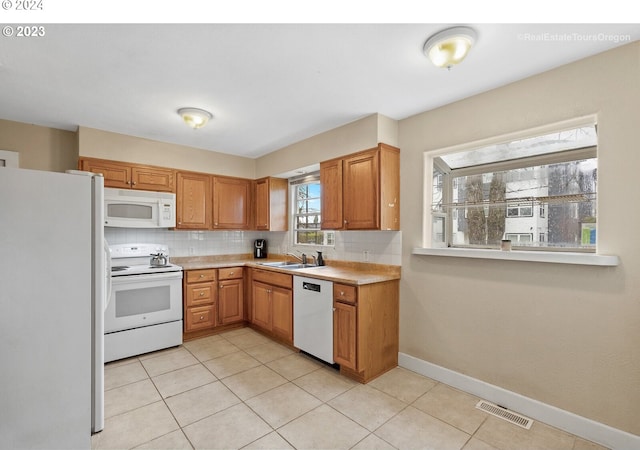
254 177 289 231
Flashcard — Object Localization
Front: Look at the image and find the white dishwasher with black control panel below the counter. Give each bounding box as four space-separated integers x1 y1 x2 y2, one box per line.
293 276 334 364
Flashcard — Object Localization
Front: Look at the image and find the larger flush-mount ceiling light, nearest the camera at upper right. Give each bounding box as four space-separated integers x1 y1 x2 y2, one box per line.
422 27 476 69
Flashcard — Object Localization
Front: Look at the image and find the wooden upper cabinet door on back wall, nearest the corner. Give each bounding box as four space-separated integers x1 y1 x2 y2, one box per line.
213 177 251 230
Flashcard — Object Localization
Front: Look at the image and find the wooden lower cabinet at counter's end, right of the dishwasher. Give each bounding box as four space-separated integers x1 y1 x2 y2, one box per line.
333 280 400 383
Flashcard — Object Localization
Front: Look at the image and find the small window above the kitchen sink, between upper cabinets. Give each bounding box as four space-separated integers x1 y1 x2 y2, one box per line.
290 174 335 245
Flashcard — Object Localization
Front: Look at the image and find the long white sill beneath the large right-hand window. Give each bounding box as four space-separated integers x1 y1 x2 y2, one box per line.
412 247 620 267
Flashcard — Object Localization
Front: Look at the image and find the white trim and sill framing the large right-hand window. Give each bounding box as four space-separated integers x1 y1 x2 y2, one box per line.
412 115 620 266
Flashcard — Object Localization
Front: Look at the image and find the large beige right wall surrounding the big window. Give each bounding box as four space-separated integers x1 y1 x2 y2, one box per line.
399 43 640 435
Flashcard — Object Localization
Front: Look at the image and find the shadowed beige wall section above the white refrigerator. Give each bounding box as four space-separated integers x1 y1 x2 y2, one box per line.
0 119 78 172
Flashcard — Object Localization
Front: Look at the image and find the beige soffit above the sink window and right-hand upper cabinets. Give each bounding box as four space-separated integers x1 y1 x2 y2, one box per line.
256 114 398 178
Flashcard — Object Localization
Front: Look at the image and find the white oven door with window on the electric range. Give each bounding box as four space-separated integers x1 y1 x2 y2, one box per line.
104 272 182 333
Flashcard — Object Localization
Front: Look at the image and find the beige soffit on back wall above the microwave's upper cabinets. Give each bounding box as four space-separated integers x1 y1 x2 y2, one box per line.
78 127 255 179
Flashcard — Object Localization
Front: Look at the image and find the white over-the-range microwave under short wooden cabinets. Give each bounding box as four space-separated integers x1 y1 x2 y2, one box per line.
104 188 176 228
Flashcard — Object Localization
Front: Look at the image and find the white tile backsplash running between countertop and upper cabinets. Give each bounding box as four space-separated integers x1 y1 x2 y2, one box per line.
105 227 402 265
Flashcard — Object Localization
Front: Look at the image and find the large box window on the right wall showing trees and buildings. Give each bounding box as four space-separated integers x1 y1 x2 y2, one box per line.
431 123 598 251
